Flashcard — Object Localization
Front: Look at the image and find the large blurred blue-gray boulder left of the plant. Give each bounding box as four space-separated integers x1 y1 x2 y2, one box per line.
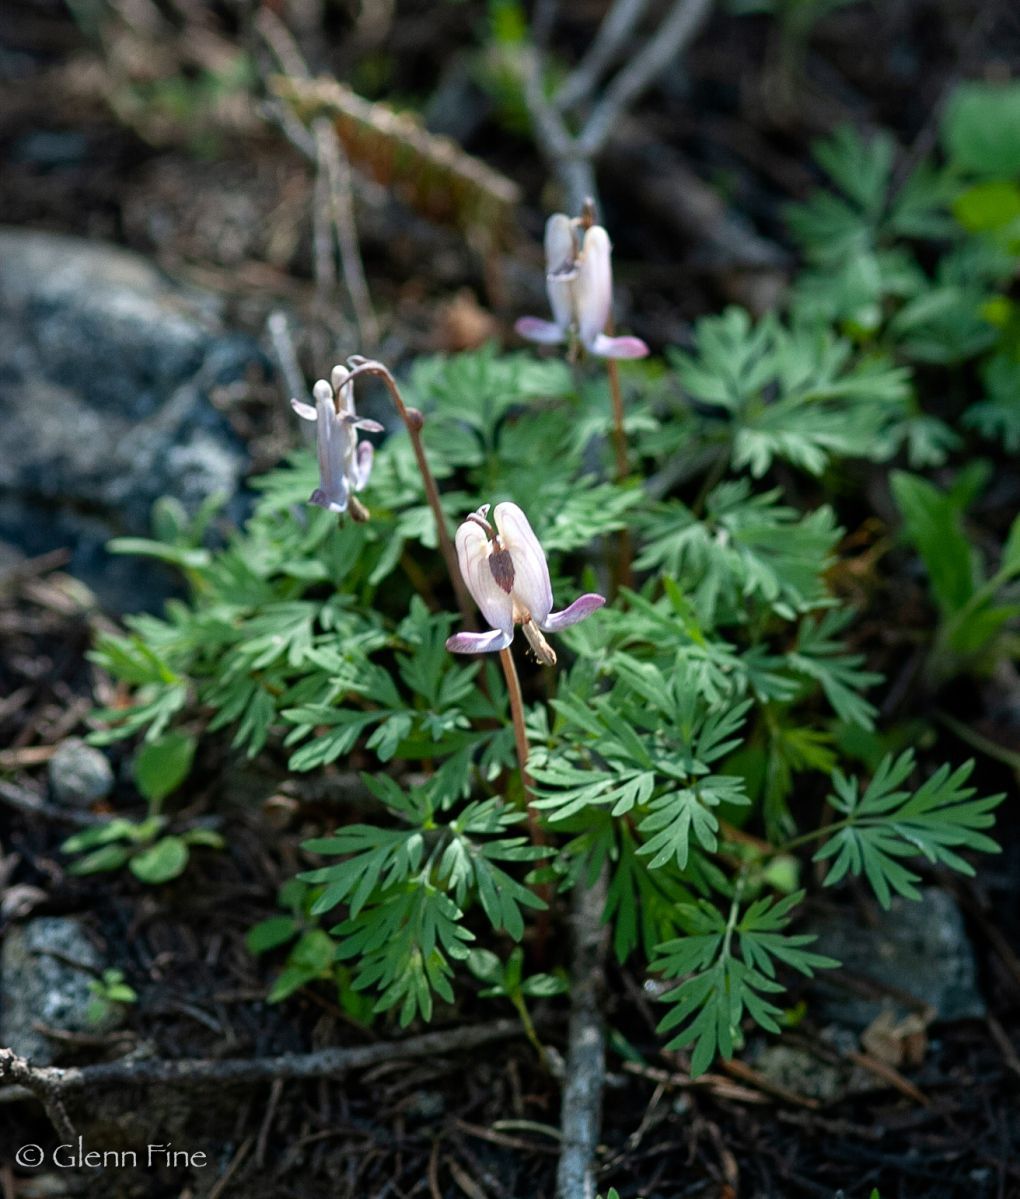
0 229 265 610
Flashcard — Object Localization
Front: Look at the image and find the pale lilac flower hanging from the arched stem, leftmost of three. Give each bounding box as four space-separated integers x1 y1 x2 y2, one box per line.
290 366 382 520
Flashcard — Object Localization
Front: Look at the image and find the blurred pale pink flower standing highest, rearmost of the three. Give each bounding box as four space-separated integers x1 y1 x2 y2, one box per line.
514 212 648 359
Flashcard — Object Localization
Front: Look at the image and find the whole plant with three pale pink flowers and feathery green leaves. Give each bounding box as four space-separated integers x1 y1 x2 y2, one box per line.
81 95 1001 1072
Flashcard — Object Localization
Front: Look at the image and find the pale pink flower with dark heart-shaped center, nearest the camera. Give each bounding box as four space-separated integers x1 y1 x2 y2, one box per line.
446 504 605 667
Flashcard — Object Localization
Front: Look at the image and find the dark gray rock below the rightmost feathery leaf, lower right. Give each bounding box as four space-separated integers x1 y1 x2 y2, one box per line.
805 887 985 1029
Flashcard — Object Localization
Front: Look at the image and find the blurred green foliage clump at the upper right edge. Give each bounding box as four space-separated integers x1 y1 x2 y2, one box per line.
789 82 1020 468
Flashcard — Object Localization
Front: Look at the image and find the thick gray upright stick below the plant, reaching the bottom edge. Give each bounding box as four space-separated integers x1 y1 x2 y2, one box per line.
556 869 608 1199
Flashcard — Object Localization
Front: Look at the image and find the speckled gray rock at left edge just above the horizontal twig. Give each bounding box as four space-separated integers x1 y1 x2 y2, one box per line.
0 916 102 1066
